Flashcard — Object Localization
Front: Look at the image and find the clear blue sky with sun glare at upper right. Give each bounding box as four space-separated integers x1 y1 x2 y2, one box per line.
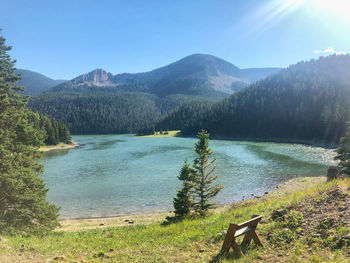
0 0 350 79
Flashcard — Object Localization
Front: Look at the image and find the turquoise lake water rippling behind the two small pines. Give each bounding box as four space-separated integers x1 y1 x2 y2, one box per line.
41 135 334 218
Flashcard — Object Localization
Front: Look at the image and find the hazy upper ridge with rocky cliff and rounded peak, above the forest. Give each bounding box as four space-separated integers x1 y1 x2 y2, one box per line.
54 54 249 98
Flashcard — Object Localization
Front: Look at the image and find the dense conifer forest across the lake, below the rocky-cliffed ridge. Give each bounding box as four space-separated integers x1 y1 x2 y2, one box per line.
29 91 213 134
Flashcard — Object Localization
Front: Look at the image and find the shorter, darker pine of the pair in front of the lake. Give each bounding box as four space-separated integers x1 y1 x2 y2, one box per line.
163 160 194 225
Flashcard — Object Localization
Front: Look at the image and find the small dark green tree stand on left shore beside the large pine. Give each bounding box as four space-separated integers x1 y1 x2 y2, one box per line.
36 115 72 145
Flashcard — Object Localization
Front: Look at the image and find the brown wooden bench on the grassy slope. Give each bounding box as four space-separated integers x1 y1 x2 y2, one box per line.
220 215 263 256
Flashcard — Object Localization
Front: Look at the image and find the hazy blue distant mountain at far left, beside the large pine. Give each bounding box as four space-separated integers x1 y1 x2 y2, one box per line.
16 69 66 95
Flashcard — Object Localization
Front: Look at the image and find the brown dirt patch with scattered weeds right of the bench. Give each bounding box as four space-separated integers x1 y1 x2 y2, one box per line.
266 186 350 262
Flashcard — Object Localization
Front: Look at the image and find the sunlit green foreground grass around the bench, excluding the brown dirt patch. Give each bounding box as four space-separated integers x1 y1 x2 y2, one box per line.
0 179 350 262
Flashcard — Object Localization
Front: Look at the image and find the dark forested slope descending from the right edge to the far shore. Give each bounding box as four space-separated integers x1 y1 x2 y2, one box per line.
161 55 350 145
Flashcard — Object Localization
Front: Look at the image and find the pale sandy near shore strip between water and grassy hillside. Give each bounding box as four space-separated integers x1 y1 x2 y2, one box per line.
55 176 327 232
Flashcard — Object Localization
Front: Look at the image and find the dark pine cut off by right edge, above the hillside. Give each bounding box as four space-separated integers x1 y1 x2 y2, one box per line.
334 122 350 176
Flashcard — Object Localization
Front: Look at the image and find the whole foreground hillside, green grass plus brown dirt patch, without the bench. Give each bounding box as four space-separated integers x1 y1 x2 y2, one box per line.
0 178 350 262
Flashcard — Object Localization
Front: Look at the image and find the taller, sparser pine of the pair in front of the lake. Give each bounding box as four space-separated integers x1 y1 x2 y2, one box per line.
193 130 222 216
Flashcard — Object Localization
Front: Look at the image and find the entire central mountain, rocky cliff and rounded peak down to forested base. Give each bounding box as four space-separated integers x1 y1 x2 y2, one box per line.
29 54 249 134
